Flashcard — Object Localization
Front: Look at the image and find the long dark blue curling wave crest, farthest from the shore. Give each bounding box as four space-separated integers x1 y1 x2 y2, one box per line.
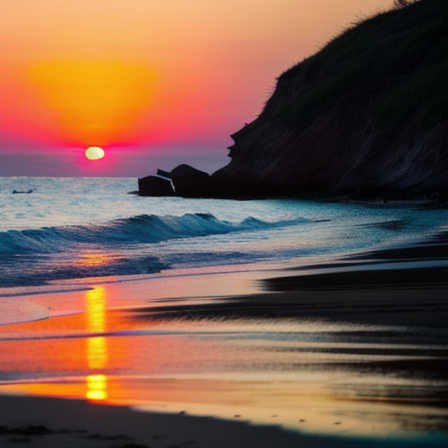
0 213 307 256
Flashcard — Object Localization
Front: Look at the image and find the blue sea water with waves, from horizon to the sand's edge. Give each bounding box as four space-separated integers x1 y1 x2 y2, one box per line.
0 177 448 287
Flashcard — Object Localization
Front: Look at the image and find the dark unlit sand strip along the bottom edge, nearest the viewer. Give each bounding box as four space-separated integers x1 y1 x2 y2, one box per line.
0 394 448 448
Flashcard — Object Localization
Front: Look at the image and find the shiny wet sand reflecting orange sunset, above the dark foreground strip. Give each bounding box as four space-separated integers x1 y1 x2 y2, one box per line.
0 279 448 437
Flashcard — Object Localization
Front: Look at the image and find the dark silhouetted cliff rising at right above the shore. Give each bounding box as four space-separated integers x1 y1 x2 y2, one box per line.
210 0 448 200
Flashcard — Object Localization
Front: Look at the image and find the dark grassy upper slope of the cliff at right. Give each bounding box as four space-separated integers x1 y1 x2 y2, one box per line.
275 0 448 130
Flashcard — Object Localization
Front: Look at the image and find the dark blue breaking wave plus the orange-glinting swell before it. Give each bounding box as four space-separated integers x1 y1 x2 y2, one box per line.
0 213 308 287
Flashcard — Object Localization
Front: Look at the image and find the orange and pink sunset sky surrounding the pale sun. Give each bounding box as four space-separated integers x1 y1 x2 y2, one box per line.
0 0 392 177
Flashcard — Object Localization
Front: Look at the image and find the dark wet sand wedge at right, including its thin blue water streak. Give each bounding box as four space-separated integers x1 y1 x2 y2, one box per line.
124 231 448 329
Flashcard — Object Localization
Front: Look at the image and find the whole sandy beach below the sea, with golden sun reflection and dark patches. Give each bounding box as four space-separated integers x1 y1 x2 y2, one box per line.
0 231 448 448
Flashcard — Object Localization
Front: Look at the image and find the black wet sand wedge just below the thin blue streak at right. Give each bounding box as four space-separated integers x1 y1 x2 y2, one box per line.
138 268 448 328
